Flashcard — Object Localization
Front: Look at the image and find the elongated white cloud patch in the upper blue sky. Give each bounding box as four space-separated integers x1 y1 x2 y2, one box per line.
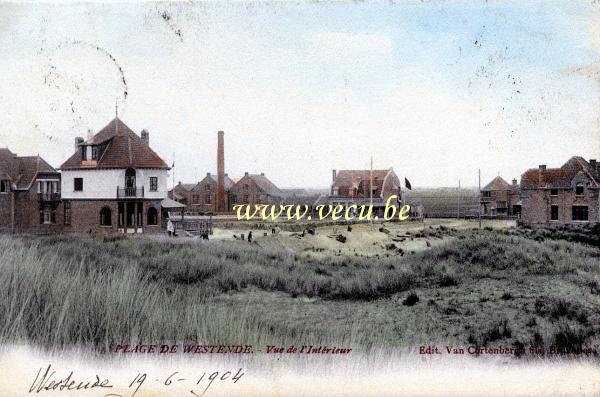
308 32 394 54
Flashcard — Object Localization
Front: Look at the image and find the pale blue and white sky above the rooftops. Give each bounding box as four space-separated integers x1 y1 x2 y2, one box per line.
0 1 600 187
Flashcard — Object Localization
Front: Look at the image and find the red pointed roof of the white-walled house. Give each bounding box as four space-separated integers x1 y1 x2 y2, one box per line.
60 118 169 170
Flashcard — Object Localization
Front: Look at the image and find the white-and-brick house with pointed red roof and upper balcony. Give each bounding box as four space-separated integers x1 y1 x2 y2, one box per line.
60 118 169 234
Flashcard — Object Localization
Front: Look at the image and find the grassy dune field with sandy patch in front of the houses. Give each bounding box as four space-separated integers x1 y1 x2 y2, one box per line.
0 220 600 350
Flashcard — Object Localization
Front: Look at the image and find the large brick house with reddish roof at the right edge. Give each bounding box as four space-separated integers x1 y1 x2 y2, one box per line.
521 156 600 225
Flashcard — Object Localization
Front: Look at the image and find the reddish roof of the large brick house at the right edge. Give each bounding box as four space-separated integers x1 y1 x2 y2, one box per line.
521 156 600 189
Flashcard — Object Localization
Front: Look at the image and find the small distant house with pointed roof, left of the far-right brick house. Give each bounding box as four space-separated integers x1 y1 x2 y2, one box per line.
479 176 521 216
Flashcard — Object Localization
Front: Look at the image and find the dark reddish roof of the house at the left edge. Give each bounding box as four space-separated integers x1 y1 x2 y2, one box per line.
0 148 58 189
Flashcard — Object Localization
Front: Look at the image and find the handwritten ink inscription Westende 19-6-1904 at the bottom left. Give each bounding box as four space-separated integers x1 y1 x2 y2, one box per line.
29 364 244 397
